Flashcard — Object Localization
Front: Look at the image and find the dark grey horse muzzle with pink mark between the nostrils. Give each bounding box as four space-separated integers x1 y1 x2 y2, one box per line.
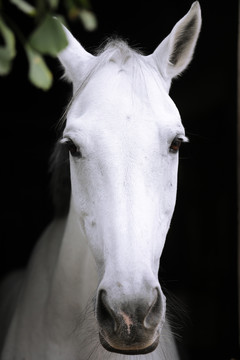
96 288 165 355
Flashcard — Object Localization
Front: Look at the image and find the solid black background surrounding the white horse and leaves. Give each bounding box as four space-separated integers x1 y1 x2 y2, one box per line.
0 0 239 360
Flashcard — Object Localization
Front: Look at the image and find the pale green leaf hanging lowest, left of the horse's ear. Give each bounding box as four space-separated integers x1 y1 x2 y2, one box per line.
25 44 53 90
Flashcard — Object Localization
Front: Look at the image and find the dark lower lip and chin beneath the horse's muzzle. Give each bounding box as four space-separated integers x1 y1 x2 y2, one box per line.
99 333 159 355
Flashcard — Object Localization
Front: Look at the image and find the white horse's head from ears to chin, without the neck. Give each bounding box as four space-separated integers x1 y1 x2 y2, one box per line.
60 3 200 354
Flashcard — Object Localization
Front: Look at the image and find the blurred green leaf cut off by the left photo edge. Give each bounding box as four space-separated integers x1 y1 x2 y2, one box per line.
0 17 16 75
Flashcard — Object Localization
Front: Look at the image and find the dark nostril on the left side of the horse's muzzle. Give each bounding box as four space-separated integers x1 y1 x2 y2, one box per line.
97 290 117 332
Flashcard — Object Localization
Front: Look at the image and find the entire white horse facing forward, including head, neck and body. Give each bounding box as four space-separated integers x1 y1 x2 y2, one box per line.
1 2 201 360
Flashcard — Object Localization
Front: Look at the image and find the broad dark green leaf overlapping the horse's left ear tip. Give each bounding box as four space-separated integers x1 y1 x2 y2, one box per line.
29 14 68 57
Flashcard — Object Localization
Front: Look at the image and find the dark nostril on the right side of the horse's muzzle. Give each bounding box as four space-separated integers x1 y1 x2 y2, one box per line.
143 288 163 329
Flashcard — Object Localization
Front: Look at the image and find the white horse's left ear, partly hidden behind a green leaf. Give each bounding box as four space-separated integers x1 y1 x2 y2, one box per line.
58 25 94 87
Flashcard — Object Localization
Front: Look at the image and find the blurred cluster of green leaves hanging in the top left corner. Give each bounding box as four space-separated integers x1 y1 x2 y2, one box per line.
0 0 97 90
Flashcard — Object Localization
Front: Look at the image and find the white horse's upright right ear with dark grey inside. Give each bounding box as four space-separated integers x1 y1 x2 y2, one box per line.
151 1 201 84
